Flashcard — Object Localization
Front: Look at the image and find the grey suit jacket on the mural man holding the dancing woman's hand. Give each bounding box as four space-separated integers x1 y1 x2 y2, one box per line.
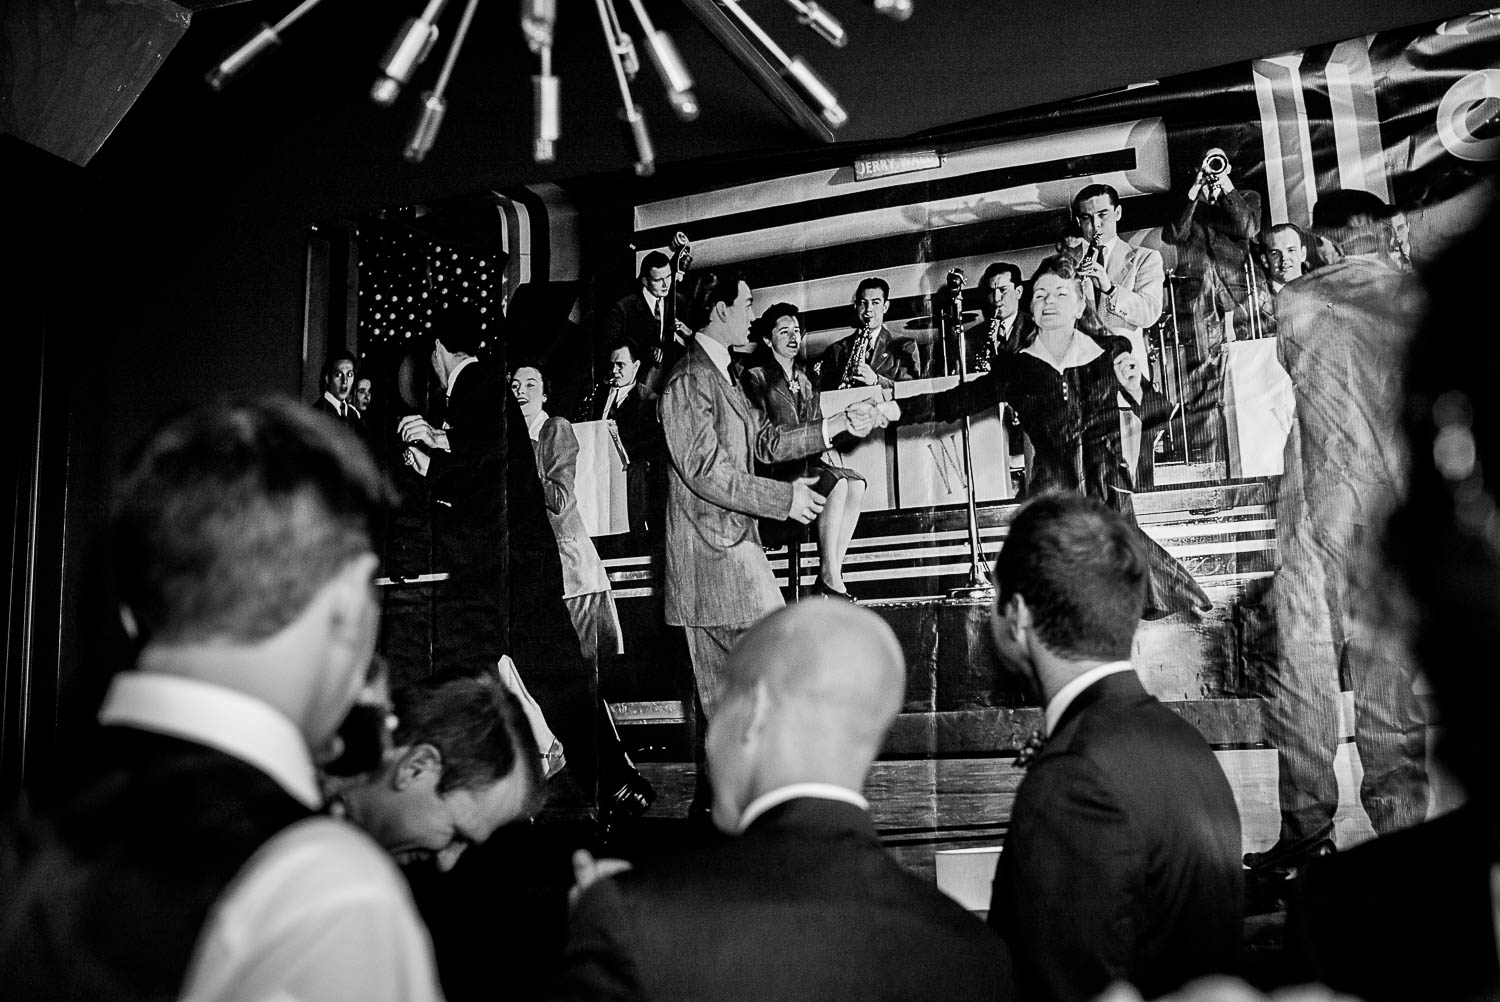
662 342 825 626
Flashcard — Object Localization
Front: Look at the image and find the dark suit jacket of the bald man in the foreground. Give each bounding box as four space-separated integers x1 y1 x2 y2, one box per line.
563 798 1011 1002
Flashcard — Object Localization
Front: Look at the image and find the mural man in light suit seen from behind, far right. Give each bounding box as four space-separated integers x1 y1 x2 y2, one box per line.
1247 189 1428 870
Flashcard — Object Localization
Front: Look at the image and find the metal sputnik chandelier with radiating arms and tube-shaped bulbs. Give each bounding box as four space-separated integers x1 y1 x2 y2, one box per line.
206 0 914 177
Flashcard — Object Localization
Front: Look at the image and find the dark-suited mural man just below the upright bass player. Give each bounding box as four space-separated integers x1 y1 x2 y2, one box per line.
591 338 666 533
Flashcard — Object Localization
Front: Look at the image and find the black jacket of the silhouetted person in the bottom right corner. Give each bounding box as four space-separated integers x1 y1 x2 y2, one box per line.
1287 803 1500 1002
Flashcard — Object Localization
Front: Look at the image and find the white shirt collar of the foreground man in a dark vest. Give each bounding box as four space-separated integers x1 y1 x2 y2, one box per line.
99 671 323 810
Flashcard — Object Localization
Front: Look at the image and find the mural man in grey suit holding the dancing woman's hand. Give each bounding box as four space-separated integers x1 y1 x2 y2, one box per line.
662 272 885 806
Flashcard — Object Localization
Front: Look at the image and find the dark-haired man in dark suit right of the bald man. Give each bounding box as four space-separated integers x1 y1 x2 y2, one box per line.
990 494 1244 1002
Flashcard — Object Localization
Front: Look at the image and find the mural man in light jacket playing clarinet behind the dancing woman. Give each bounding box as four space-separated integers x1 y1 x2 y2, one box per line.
1073 185 1166 488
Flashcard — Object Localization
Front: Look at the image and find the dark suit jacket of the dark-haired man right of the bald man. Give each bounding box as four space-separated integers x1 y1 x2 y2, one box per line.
990 672 1244 1002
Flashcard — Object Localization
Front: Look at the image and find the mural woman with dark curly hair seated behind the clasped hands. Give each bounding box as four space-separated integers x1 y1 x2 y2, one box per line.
740 303 864 599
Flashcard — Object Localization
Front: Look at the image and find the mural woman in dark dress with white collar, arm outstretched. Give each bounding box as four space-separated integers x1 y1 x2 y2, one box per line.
903 255 1211 618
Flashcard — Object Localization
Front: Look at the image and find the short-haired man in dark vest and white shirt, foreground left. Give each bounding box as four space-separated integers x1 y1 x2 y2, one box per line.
0 401 440 1002
